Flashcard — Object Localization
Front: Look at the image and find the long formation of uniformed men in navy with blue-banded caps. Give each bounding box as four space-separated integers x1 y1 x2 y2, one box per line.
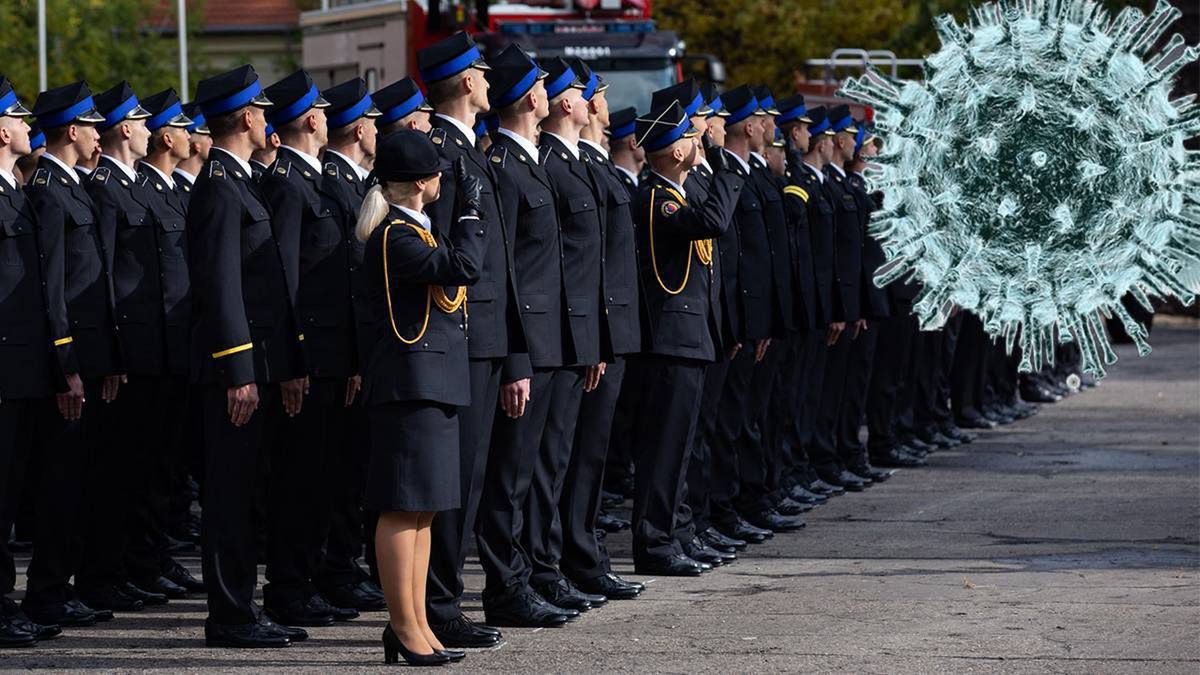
0 28 1070 661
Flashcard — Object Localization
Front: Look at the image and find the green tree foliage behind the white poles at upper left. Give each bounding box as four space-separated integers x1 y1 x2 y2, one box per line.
0 0 206 100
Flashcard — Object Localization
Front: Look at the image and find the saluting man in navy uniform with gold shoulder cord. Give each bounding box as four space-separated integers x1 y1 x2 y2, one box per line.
634 101 745 577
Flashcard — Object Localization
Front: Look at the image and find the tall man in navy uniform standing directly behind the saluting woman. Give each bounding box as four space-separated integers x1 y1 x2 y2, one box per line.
416 32 529 646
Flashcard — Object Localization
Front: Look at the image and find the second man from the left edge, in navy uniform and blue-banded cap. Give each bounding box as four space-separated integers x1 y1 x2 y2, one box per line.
23 82 124 625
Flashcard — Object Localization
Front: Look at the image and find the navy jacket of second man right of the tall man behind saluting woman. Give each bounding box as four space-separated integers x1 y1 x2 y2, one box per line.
539 133 607 365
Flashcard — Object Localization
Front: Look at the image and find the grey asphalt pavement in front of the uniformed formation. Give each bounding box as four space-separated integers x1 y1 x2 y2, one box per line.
0 324 1200 673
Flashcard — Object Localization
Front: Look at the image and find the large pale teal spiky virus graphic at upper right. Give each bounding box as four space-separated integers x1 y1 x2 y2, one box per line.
841 0 1200 376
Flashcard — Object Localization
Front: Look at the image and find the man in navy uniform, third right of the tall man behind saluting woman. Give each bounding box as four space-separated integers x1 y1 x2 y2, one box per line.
561 59 644 599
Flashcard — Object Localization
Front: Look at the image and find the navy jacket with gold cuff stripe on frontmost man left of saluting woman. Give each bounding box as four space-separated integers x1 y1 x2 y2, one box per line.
187 148 305 387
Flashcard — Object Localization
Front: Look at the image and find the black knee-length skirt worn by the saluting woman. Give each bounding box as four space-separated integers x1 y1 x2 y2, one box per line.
366 401 462 512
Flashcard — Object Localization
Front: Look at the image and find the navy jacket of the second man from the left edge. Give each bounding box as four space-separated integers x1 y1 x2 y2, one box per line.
25 157 124 377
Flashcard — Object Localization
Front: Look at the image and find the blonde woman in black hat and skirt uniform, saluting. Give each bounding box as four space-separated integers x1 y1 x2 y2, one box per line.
356 130 487 665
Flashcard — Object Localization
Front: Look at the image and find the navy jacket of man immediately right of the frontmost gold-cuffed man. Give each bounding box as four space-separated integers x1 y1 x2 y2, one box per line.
259 148 358 378
